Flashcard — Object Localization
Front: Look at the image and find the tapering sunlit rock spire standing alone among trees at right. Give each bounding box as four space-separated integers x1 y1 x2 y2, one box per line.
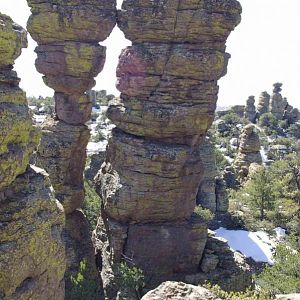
234 124 262 182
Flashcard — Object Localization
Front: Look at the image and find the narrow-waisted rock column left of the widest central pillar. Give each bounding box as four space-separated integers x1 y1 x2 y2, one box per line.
27 0 116 296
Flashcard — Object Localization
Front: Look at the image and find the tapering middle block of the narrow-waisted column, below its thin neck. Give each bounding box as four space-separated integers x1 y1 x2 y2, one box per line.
36 119 90 214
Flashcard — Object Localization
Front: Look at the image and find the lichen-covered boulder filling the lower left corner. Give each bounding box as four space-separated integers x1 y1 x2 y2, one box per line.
0 168 66 300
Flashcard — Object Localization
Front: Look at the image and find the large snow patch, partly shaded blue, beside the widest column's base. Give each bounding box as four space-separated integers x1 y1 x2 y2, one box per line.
216 227 276 264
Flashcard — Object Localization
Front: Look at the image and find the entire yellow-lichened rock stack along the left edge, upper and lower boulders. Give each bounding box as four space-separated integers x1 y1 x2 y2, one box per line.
0 14 66 300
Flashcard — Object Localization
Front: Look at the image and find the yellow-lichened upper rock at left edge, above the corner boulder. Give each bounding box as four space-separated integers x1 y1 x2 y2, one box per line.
0 14 38 189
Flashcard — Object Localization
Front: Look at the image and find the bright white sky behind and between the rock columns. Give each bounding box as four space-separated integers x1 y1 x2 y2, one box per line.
0 0 300 107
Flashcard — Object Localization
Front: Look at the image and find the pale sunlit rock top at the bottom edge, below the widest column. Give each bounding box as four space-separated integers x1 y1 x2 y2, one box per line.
142 281 220 300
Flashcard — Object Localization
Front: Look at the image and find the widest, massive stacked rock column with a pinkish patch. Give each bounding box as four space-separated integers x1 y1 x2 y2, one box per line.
96 0 241 292
